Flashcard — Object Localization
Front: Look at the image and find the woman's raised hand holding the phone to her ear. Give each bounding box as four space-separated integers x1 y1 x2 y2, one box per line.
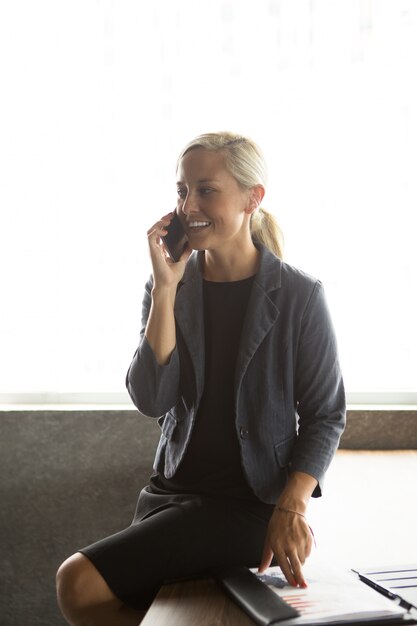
148 212 192 289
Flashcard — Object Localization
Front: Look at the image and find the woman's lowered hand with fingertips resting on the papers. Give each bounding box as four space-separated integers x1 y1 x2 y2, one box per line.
259 507 314 587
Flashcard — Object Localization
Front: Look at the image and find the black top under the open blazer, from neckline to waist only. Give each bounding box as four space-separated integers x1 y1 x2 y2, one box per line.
151 277 255 500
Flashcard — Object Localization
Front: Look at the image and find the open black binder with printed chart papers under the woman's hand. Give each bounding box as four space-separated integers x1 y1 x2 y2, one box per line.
215 563 417 626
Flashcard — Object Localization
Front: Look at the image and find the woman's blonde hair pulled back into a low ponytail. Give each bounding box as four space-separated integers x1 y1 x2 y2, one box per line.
177 132 283 258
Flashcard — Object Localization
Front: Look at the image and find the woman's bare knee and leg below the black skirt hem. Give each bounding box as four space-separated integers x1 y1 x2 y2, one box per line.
57 553 145 626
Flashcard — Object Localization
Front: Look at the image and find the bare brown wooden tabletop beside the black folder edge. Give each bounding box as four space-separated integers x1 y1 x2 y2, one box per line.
141 579 254 626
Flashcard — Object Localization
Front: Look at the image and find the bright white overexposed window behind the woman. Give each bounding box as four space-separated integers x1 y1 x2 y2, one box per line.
0 0 417 400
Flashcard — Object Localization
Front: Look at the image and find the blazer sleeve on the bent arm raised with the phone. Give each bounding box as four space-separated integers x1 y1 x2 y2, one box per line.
126 278 180 417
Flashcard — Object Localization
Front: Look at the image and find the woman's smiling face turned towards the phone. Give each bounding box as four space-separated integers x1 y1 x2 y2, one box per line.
177 148 256 250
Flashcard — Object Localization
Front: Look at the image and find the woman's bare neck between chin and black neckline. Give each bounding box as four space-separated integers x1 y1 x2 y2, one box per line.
203 241 259 282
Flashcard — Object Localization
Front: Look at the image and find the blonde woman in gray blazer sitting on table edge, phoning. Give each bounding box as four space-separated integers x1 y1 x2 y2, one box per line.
58 133 345 626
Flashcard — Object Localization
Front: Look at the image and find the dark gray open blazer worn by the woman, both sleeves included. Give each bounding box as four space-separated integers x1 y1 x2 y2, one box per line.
126 245 346 503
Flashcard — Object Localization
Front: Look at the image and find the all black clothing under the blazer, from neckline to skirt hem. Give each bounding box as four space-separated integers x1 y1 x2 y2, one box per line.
80 277 273 609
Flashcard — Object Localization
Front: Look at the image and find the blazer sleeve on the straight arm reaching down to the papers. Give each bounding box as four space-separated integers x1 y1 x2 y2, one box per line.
291 281 346 497
